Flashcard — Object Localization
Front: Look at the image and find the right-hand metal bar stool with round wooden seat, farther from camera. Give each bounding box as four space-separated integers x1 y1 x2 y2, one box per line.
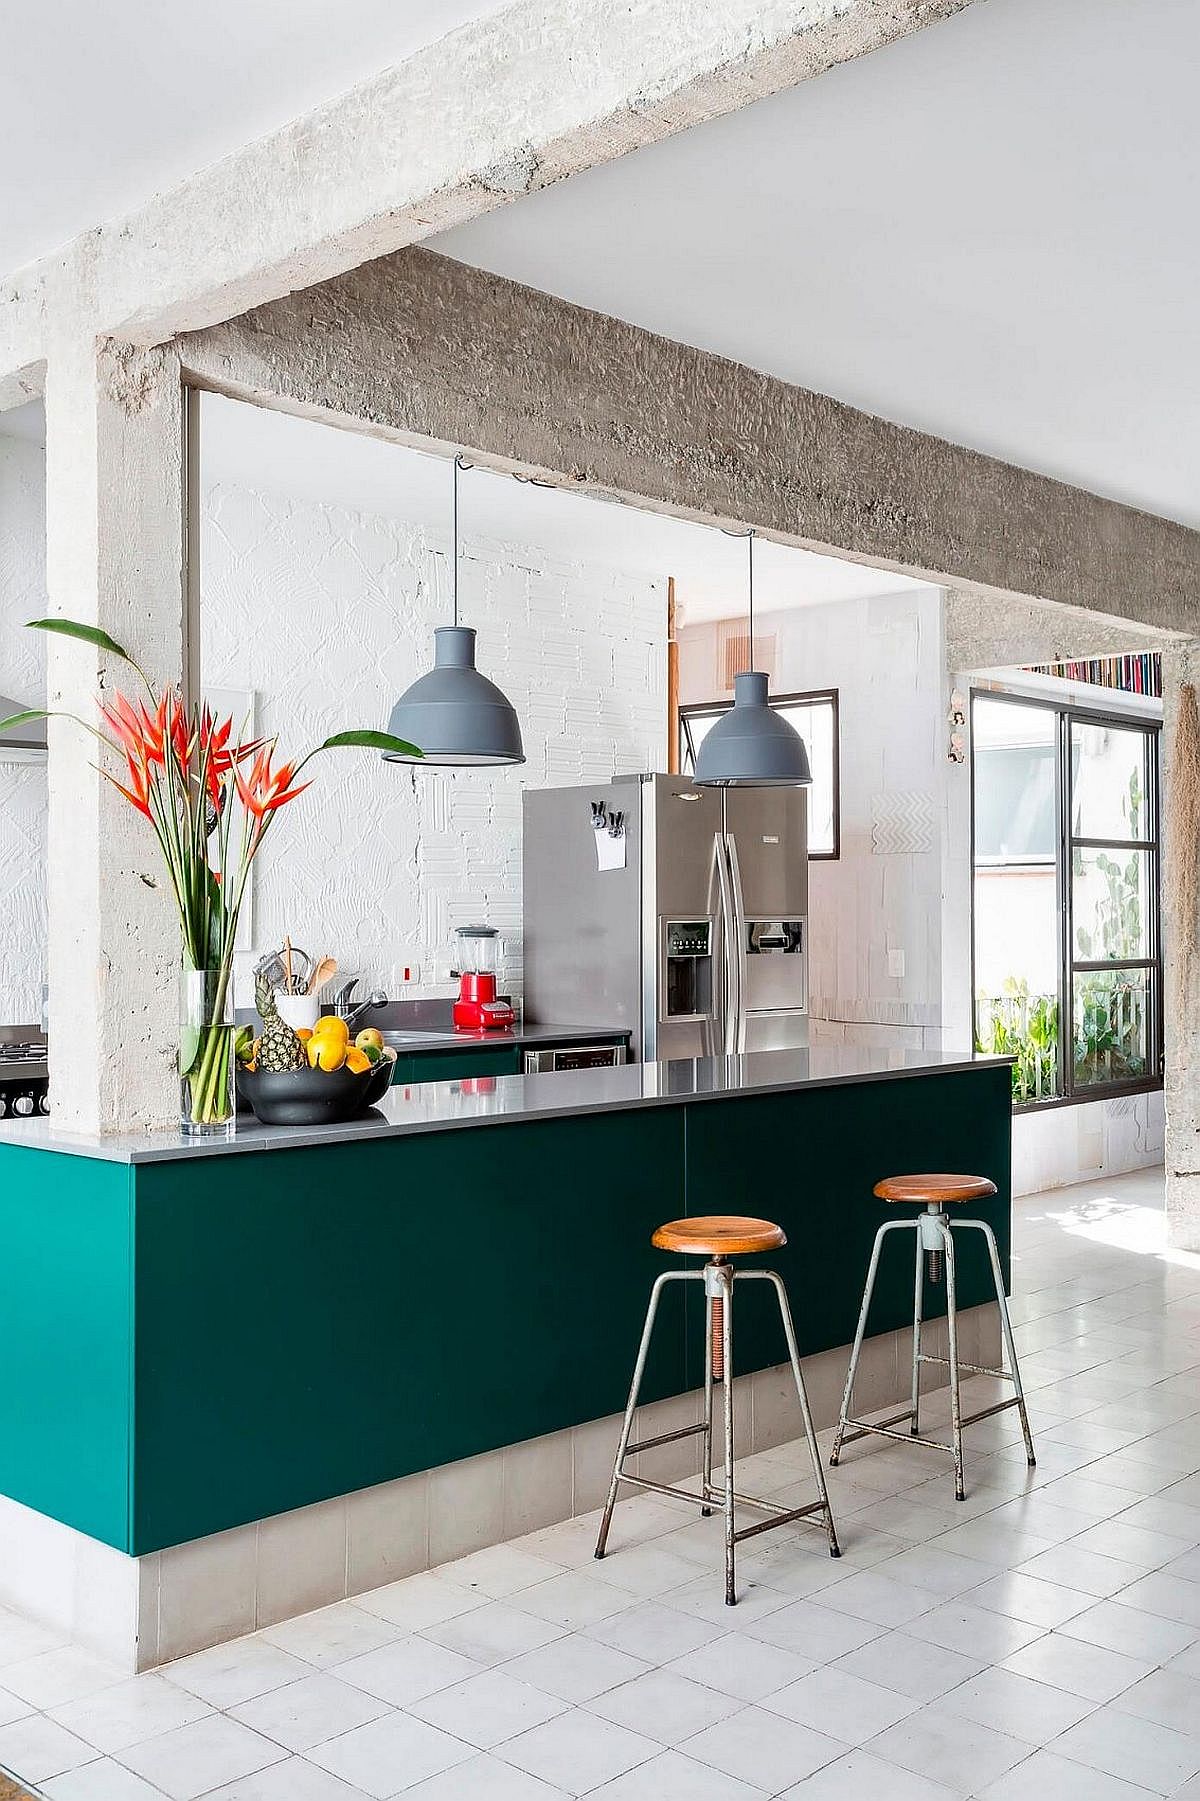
829 1176 1036 1500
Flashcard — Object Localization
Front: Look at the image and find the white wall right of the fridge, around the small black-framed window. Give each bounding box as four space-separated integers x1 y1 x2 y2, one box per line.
679 587 946 1048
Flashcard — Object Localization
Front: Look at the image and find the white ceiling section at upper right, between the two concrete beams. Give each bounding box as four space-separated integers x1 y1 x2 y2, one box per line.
434 0 1200 524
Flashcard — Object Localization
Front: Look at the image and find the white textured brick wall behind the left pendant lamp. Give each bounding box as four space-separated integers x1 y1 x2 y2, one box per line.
202 484 667 987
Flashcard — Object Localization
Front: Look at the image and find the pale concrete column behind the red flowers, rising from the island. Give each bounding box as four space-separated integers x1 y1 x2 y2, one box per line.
45 335 184 1131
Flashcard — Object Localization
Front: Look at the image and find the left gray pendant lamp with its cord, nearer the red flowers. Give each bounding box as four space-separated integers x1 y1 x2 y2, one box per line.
384 456 524 767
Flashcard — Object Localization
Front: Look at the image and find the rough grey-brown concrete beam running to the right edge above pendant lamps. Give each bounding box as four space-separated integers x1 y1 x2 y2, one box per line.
180 249 1200 634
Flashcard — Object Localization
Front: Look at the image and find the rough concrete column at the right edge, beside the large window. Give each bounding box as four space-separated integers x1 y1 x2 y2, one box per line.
1162 639 1200 1250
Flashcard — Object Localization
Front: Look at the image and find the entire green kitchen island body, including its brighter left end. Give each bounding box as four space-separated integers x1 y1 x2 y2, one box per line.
0 1046 1011 1554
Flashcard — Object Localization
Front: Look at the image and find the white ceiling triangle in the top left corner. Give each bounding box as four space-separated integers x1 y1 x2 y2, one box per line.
0 0 503 276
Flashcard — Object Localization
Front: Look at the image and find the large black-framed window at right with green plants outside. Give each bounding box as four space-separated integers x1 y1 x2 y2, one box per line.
971 692 1162 1106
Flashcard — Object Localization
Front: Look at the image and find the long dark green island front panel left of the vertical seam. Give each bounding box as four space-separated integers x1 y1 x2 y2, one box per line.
130 1108 685 1554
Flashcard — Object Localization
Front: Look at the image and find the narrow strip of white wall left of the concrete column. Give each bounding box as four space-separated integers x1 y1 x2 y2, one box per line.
0 438 47 1025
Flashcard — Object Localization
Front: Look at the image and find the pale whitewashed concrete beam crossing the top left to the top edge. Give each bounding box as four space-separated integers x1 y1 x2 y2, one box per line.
0 0 969 365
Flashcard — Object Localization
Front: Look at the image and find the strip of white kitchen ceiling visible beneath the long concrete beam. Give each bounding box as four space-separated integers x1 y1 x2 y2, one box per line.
0 394 919 625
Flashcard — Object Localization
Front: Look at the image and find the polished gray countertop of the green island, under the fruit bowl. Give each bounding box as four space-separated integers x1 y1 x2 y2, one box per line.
0 1045 1013 1163
